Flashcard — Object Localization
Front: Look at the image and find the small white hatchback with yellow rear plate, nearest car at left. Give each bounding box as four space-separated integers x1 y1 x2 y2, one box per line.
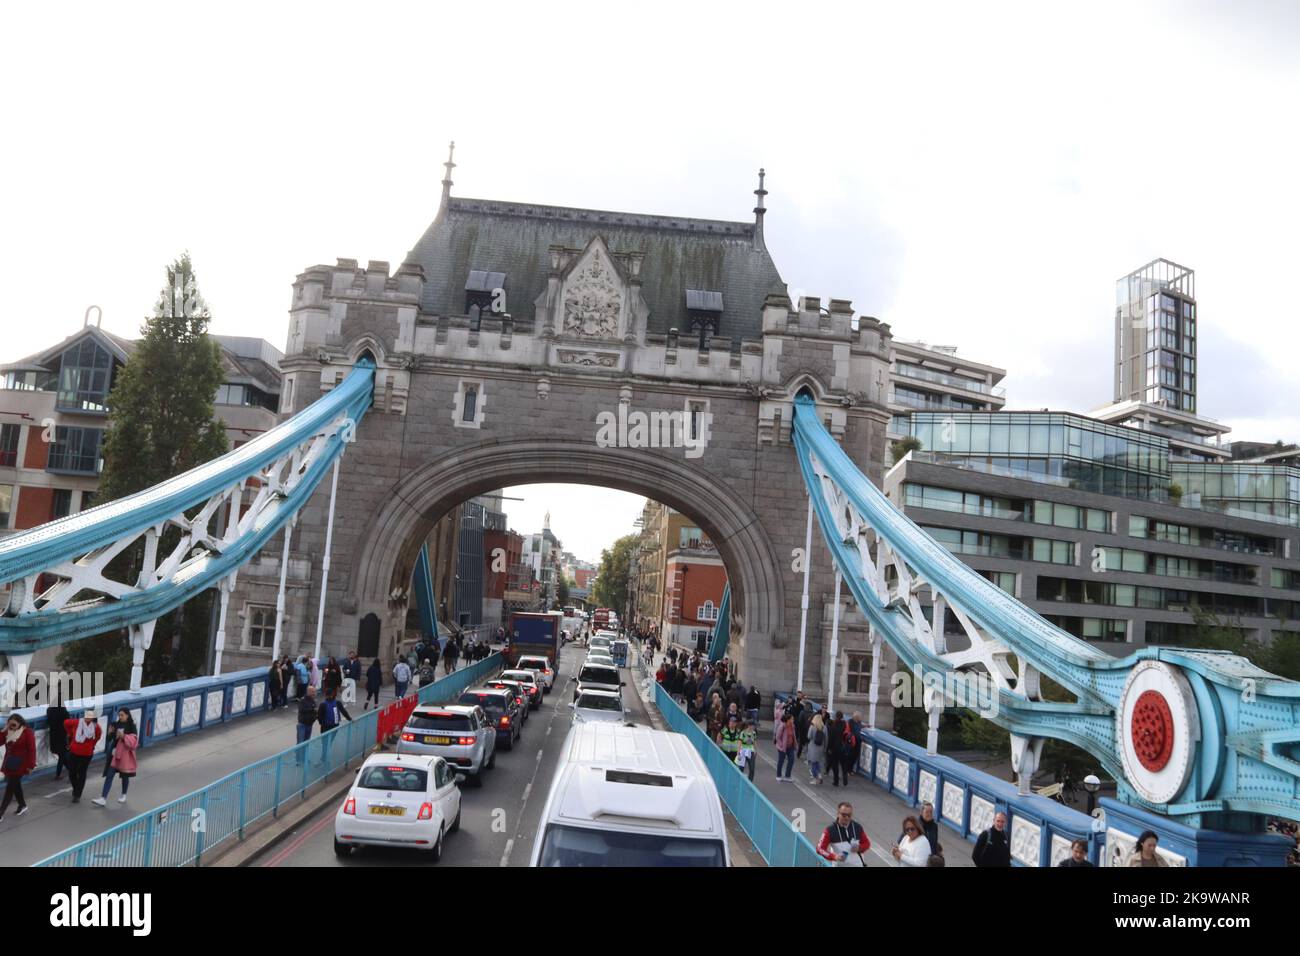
334 753 460 862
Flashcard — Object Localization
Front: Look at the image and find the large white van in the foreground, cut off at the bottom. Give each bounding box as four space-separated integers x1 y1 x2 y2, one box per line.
530 722 731 866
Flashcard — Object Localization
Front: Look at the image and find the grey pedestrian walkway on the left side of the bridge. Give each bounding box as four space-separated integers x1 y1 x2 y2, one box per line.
0 684 405 866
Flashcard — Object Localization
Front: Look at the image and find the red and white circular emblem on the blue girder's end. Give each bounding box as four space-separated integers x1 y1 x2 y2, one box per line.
1115 661 1200 804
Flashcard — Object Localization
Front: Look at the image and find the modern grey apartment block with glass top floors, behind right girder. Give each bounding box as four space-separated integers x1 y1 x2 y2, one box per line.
885 412 1300 654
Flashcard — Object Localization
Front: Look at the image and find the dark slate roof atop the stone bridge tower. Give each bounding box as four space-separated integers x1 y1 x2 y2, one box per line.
407 196 785 338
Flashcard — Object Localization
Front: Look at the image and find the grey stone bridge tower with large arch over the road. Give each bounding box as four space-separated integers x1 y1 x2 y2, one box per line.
271 160 889 688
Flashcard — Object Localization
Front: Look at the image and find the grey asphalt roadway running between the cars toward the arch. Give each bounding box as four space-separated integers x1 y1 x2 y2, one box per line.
250 646 763 866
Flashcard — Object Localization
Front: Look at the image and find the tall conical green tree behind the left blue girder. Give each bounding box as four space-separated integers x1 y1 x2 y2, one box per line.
59 254 228 691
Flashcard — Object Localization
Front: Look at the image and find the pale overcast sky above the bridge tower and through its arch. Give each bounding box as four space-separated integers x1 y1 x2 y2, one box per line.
0 0 1300 559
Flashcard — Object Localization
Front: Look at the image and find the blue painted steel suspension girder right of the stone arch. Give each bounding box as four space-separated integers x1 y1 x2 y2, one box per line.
794 395 1300 822
